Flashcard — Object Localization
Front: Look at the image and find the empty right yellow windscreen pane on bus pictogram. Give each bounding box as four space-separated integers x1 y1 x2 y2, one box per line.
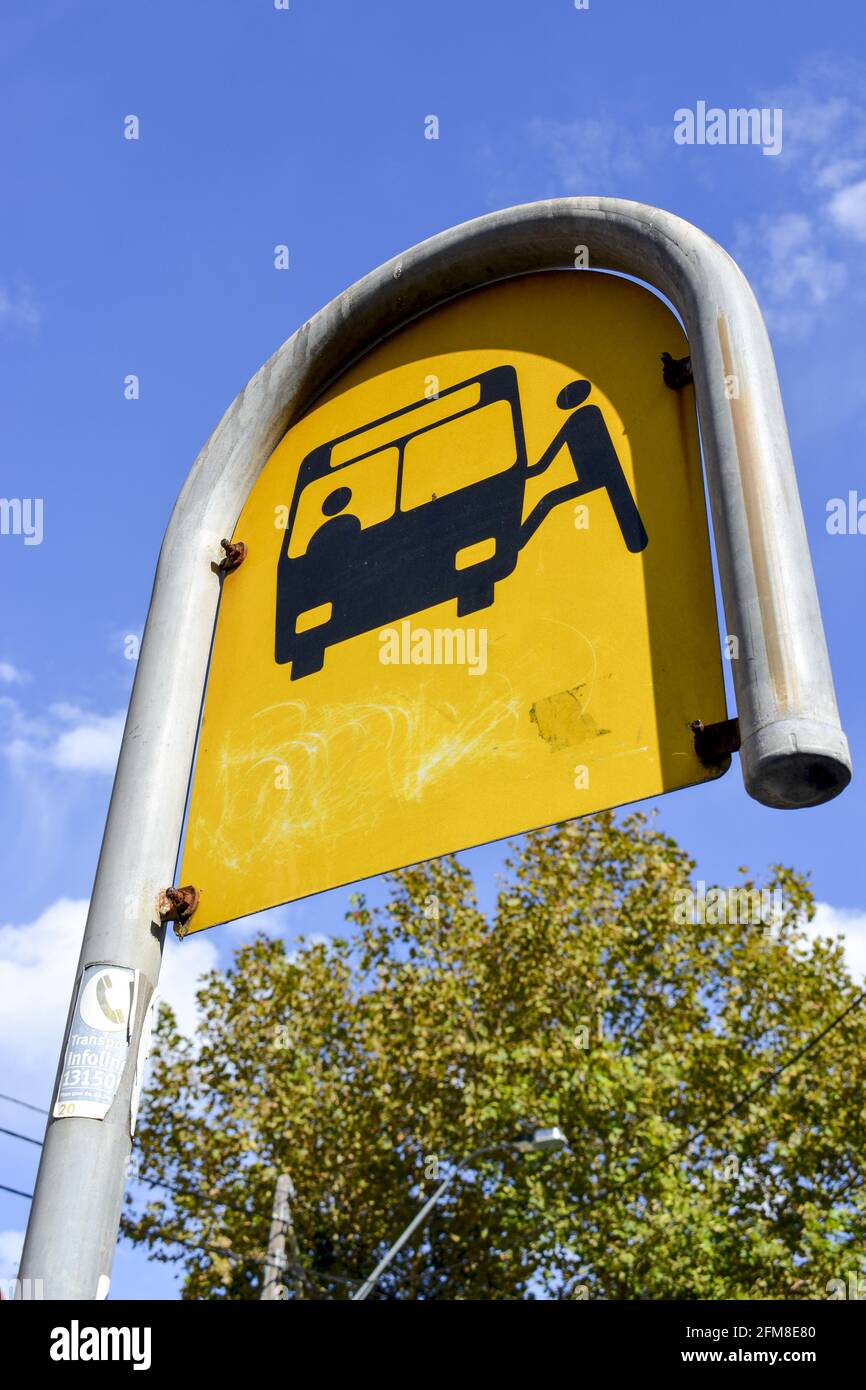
400 400 517 512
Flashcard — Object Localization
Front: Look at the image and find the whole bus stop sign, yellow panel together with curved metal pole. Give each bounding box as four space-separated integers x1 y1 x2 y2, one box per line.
19 205 851 1300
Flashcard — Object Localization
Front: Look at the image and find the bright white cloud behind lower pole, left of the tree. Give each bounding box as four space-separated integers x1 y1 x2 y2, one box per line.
0 898 218 1084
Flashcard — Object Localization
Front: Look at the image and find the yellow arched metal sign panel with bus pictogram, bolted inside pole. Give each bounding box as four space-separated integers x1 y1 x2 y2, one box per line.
182 271 726 931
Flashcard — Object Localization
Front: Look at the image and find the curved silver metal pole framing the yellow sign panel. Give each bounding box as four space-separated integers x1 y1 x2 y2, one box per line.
21 197 851 1298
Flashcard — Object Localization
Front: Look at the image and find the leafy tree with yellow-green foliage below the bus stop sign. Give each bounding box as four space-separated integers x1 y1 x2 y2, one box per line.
124 813 866 1300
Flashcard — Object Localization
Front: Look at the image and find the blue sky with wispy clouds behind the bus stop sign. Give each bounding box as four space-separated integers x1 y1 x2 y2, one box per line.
0 0 866 1297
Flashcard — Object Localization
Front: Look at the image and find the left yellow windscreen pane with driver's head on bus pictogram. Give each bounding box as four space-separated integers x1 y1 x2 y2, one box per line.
288 446 400 560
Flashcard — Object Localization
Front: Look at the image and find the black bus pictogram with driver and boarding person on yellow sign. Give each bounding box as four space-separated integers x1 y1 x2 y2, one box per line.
275 366 646 680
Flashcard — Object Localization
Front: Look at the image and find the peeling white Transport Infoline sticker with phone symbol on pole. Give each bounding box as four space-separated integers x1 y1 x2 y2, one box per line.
53 965 138 1120
